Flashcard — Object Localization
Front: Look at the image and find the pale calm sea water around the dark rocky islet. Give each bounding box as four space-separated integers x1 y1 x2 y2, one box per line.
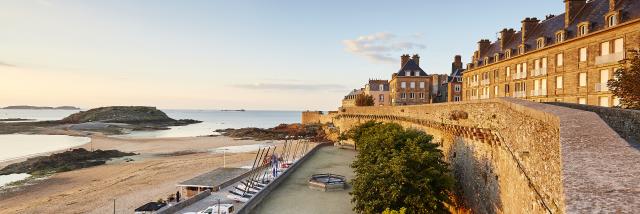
0 109 301 187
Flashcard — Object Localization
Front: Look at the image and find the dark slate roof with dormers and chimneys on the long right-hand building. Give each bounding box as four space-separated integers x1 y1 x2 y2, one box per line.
477 0 640 65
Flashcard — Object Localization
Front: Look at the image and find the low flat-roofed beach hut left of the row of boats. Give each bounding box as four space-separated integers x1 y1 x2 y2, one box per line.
178 168 251 198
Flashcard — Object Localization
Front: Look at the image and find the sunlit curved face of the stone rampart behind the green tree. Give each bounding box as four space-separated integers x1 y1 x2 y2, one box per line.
334 100 564 213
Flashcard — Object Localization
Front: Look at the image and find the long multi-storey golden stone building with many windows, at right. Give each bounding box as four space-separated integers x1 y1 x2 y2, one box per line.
463 0 640 106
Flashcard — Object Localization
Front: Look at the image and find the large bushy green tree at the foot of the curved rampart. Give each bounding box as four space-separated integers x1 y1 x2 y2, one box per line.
343 122 454 213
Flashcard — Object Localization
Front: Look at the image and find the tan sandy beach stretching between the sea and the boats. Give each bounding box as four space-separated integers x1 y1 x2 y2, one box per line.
0 135 277 213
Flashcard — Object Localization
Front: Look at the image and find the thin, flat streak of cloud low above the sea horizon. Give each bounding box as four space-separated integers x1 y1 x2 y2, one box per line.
233 83 346 91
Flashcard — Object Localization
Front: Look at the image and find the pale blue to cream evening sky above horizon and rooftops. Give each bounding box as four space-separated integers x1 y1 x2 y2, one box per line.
0 0 564 110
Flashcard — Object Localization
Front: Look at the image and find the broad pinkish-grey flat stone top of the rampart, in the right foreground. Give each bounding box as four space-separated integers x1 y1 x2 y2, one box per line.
503 98 640 213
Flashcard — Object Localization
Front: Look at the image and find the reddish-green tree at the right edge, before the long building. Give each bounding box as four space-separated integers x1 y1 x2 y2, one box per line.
607 51 640 109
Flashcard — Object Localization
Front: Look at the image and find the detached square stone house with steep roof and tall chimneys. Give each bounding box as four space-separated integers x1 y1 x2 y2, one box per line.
389 54 432 106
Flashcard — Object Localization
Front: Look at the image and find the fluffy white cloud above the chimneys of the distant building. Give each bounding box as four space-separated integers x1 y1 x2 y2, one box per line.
342 32 426 63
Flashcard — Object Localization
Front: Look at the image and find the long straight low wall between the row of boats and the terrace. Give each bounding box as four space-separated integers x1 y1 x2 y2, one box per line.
236 143 331 214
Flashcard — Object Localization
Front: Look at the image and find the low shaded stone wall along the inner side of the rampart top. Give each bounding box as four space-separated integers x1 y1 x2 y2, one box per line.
548 102 640 143
